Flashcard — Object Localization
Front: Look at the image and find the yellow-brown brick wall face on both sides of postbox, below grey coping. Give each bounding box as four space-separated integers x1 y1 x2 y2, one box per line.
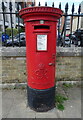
2 56 81 83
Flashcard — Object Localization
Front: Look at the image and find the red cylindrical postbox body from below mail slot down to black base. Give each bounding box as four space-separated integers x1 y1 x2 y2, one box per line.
26 24 56 89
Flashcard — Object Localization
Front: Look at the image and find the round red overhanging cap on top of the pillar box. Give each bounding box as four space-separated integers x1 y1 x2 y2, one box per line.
19 6 63 21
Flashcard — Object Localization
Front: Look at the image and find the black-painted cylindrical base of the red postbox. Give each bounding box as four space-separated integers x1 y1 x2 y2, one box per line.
27 87 55 112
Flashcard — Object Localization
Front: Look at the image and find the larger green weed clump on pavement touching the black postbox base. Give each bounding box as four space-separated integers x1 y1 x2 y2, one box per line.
55 94 68 110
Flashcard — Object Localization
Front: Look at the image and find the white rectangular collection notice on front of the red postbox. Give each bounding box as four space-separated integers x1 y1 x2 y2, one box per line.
37 34 47 51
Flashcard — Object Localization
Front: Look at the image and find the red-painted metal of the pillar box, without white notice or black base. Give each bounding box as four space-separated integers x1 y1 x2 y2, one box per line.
20 7 62 89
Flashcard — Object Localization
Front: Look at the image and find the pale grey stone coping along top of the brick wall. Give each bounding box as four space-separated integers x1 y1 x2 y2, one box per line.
0 46 83 57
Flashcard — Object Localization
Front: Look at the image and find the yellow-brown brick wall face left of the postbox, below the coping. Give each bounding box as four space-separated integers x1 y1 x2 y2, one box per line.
2 57 26 83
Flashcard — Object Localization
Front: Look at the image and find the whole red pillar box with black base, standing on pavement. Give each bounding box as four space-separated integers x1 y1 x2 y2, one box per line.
19 6 62 111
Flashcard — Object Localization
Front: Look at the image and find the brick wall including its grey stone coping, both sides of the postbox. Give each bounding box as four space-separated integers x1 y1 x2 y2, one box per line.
0 47 83 83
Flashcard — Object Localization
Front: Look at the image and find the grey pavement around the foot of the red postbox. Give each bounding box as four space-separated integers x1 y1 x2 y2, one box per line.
2 86 81 119
